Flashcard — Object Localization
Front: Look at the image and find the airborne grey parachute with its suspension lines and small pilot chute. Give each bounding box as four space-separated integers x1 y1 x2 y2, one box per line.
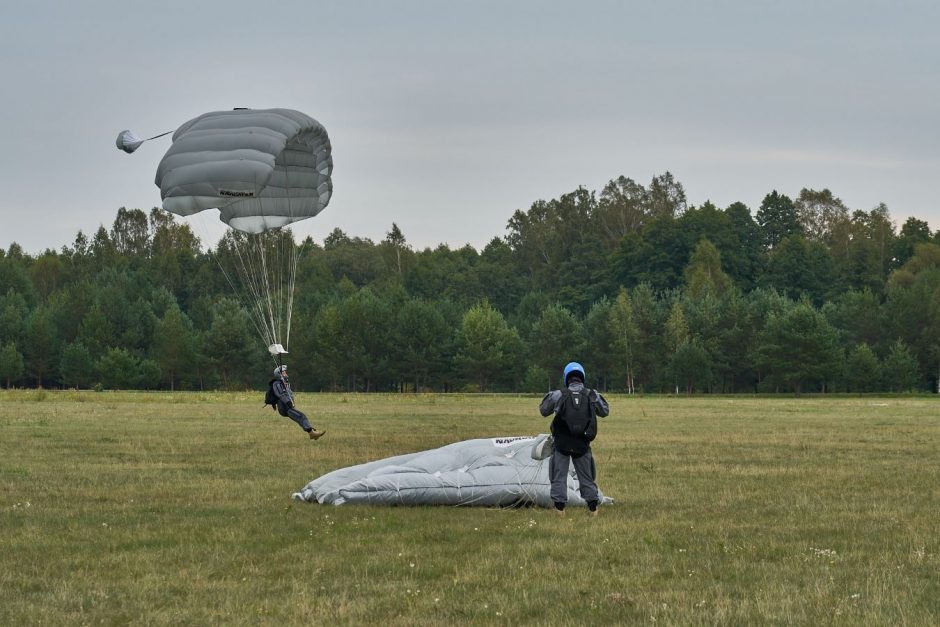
116 109 333 355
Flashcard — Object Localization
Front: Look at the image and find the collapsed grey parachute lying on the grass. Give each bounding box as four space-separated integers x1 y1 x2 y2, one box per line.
293 435 613 507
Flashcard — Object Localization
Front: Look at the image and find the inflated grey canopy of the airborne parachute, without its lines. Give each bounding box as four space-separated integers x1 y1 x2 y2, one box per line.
155 109 333 233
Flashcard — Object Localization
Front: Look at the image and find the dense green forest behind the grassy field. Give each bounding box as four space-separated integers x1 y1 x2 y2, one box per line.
0 172 940 393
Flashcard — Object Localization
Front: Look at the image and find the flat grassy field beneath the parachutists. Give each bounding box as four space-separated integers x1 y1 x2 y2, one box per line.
0 391 940 625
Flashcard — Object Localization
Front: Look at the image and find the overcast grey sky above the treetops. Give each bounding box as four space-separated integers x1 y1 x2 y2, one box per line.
0 0 940 253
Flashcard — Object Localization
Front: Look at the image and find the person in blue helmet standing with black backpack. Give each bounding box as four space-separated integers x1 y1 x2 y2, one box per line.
539 361 610 516
